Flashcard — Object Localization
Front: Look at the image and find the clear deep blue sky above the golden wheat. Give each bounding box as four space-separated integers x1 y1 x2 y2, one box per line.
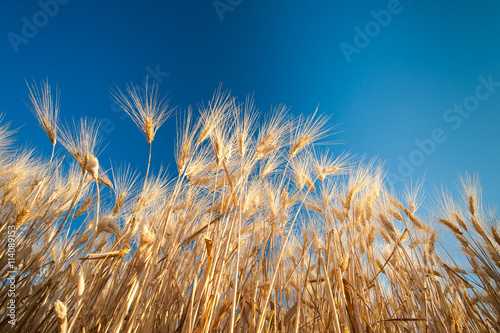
0 0 500 210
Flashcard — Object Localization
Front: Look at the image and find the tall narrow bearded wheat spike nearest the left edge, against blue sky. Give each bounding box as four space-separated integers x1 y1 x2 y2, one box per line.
26 79 59 145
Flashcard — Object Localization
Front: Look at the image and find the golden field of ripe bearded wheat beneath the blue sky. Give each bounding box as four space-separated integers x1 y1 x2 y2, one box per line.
0 81 500 333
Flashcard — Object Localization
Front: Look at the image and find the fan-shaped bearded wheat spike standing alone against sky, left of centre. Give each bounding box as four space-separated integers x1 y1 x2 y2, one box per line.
111 81 173 143
